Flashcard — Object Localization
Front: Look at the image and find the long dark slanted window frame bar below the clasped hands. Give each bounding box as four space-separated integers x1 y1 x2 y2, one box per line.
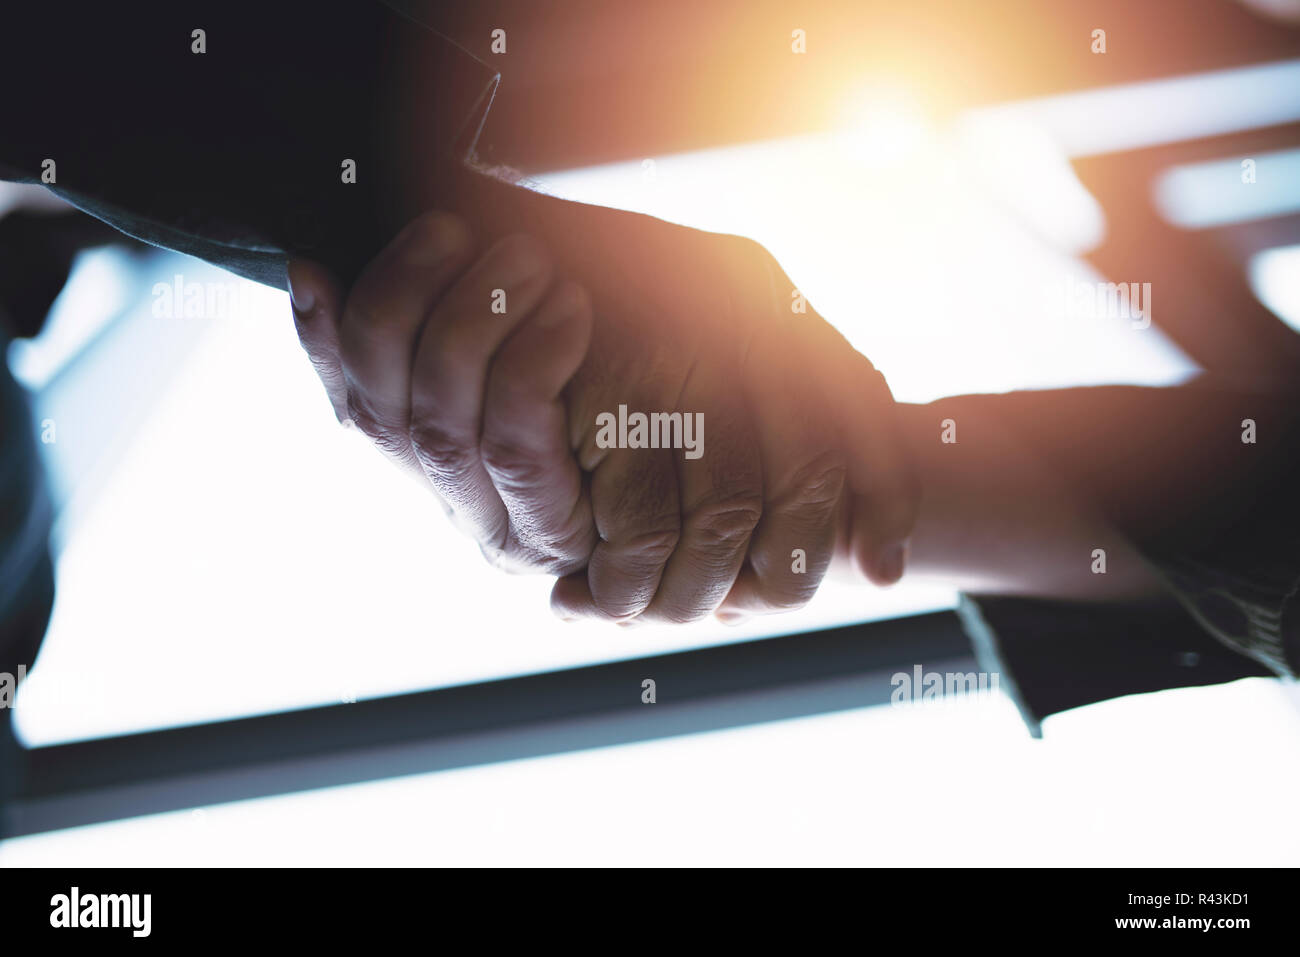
5 611 979 837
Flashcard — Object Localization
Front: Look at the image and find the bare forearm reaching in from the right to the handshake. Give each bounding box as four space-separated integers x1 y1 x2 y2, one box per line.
900 381 1296 598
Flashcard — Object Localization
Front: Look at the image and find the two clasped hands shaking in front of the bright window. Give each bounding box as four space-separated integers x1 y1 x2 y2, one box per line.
289 178 919 623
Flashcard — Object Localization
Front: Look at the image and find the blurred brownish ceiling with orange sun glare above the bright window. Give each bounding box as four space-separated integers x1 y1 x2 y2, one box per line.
403 0 1300 172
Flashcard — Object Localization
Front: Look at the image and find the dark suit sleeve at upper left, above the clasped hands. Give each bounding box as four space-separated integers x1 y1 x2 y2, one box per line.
0 0 497 287
